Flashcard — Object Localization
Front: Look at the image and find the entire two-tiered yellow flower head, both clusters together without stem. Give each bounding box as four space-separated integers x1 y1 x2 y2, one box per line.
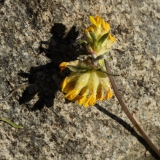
60 16 116 107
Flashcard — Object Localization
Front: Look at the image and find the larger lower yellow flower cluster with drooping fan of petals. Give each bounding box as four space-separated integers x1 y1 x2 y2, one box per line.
60 65 113 107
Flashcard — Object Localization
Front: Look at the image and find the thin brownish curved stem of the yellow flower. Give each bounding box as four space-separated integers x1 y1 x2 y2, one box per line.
104 59 160 157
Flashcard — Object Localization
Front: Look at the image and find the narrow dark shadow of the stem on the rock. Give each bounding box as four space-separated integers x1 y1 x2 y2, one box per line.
95 104 160 160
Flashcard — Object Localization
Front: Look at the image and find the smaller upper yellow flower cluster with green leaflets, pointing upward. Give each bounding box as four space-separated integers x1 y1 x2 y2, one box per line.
85 16 116 58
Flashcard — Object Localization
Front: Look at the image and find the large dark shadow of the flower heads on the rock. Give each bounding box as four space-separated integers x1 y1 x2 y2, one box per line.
18 23 79 110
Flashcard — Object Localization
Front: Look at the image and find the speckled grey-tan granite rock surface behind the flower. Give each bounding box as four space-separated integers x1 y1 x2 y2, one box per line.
0 0 160 160
